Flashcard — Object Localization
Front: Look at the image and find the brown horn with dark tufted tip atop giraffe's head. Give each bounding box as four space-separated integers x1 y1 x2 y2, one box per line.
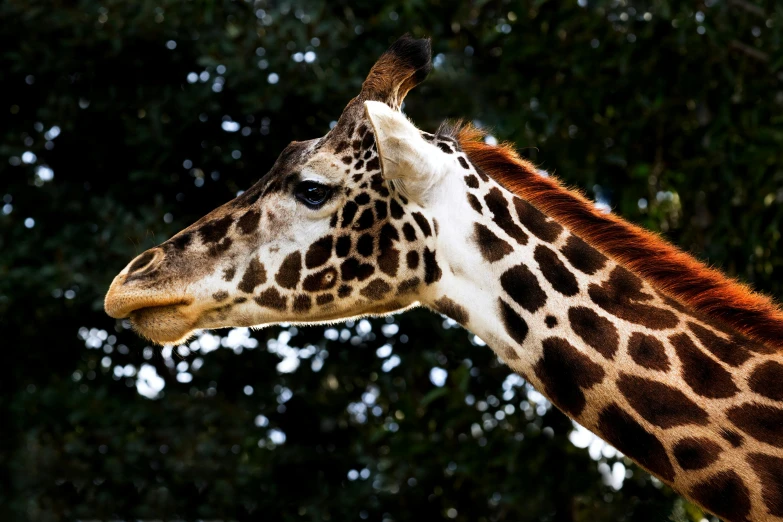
359 34 432 110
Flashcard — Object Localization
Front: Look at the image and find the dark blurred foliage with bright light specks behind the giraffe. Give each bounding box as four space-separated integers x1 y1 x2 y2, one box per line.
0 0 783 522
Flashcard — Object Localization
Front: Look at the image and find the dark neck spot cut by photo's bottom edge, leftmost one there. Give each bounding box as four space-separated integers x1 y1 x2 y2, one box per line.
690 471 750 522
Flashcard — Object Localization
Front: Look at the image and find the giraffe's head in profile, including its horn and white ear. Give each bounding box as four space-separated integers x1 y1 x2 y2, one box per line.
105 36 464 343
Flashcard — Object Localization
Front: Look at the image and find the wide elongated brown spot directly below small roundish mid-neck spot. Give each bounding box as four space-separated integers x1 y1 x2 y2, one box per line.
617 373 708 429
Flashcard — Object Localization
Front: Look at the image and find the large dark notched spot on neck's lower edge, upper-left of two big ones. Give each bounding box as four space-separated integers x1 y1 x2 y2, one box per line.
533 337 605 417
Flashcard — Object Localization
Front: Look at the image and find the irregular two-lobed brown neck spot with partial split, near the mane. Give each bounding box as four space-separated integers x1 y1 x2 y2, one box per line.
587 266 679 330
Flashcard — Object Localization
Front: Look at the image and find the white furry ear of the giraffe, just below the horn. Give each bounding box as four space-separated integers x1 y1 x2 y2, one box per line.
364 101 439 185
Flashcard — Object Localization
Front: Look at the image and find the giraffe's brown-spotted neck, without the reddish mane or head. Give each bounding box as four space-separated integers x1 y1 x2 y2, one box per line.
422 140 783 521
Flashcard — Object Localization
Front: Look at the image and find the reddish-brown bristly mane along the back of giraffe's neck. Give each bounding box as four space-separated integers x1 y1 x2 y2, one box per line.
452 125 783 347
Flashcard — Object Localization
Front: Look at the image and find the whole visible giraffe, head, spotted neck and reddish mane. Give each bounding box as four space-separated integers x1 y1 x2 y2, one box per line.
105 35 783 522
